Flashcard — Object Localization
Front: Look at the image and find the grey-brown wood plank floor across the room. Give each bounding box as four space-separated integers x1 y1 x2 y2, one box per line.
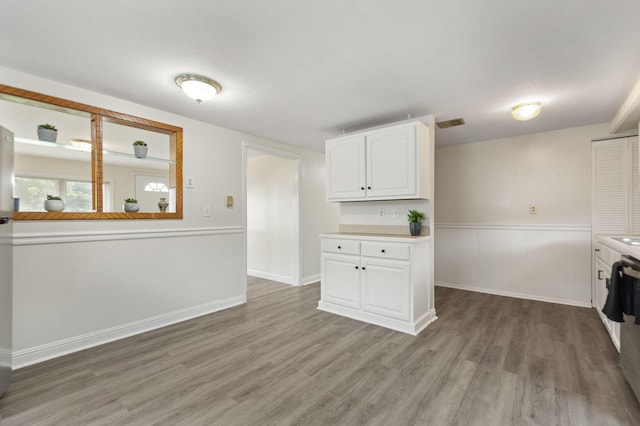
0 279 640 426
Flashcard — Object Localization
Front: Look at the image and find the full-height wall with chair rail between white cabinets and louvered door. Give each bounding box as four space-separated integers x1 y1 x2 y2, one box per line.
435 123 608 306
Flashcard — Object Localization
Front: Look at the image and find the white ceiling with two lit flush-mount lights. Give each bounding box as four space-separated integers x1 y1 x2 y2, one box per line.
0 0 640 150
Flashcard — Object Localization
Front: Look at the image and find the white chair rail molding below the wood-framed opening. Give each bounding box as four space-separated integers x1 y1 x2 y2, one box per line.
13 226 244 246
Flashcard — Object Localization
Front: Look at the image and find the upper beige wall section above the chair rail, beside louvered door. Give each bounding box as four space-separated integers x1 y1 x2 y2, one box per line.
435 123 608 225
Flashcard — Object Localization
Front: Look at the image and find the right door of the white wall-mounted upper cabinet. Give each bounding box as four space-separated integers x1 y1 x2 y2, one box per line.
367 125 418 198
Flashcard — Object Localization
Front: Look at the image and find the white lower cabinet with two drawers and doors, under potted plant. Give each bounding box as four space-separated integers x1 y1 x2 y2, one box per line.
318 234 437 335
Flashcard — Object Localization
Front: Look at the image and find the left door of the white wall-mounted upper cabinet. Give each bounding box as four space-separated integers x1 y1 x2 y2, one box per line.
325 135 366 201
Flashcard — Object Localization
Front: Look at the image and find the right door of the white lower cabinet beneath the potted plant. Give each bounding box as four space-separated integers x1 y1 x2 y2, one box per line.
361 258 411 320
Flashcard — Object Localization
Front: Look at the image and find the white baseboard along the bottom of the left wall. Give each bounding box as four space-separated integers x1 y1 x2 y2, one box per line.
13 296 246 370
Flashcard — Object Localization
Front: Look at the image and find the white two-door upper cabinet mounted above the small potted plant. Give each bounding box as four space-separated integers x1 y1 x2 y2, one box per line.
326 122 430 201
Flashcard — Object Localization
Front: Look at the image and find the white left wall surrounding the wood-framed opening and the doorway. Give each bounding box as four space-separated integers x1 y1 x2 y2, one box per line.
0 68 337 368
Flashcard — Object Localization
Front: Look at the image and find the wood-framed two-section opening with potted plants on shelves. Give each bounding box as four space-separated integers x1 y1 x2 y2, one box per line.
0 84 183 220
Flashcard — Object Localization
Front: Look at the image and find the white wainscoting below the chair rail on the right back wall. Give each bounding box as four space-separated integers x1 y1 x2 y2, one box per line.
434 224 591 307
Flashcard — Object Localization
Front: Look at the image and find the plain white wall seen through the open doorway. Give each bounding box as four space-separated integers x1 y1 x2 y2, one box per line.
247 155 297 284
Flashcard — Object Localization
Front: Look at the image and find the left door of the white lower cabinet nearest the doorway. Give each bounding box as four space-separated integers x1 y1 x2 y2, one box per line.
320 253 361 309
